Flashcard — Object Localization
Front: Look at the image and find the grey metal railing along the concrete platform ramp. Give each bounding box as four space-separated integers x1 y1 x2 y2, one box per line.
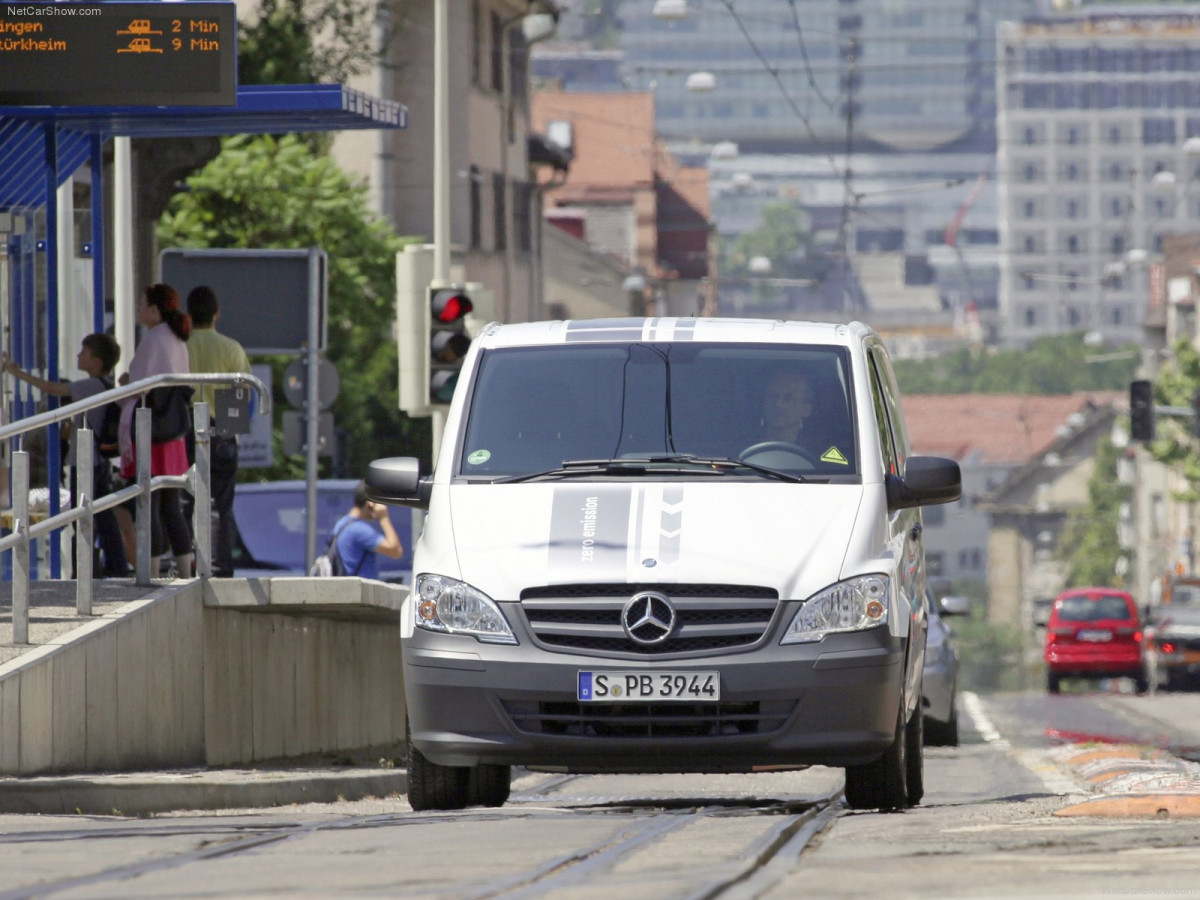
0 372 271 643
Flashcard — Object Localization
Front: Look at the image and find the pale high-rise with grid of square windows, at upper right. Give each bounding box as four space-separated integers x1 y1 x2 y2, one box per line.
997 5 1200 344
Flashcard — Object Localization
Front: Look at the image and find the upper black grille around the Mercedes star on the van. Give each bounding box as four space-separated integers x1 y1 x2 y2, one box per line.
521 584 779 658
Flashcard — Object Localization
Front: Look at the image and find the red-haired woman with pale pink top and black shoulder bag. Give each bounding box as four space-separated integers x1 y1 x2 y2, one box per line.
118 284 193 578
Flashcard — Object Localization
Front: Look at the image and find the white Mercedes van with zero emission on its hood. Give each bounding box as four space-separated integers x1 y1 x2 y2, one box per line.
367 318 961 810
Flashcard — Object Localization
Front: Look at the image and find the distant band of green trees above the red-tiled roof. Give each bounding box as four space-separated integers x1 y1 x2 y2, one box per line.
894 334 1141 394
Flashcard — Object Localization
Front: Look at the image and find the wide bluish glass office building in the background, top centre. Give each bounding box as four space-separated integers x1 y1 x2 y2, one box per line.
618 0 1037 152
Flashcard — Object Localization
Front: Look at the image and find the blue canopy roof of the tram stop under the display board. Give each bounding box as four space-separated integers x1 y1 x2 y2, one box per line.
0 84 408 211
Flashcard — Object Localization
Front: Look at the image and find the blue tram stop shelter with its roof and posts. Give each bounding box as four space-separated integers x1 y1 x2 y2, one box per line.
0 84 408 578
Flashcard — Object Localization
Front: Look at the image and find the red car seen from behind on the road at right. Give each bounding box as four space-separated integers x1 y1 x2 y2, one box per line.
1044 588 1150 694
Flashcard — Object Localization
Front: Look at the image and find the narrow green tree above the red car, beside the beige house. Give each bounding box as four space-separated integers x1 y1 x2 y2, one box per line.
1057 438 1133 587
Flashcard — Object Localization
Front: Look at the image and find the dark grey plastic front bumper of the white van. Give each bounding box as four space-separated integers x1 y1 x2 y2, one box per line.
403 628 906 773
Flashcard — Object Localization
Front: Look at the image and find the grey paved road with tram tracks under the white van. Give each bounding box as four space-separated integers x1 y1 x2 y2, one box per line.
0 694 1200 900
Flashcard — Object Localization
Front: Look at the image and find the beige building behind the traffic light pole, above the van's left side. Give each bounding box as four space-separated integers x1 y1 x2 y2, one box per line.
334 0 557 322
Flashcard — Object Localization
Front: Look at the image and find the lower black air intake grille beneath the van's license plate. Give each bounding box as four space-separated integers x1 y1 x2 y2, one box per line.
504 701 794 739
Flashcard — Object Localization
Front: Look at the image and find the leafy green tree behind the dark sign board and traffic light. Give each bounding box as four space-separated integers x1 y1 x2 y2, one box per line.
158 134 428 480
